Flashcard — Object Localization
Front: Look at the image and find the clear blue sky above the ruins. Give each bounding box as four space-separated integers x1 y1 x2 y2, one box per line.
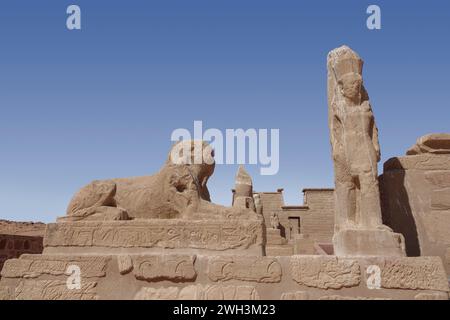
0 0 450 222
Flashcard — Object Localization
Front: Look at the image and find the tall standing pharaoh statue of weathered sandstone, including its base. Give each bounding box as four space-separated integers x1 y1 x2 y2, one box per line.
328 46 403 255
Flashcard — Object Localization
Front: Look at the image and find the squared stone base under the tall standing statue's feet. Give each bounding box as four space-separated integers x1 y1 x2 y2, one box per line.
333 229 406 257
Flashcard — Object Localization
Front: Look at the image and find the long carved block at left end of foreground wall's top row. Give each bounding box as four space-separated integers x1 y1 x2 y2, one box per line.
1 254 109 278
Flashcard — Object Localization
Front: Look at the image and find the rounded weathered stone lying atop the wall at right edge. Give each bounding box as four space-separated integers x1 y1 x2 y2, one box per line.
406 133 450 155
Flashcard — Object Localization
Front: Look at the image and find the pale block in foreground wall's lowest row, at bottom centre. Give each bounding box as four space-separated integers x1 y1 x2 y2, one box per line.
178 285 259 300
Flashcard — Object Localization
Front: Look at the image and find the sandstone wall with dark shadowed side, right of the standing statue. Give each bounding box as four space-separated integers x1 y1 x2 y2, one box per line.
380 153 450 274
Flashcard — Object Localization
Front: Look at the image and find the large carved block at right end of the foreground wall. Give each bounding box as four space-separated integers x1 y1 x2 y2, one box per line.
380 257 449 292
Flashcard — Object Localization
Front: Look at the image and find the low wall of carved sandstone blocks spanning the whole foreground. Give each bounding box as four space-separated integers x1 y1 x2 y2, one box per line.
0 253 449 300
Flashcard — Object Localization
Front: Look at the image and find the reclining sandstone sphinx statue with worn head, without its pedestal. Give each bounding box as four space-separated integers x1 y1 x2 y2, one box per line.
58 140 257 222
